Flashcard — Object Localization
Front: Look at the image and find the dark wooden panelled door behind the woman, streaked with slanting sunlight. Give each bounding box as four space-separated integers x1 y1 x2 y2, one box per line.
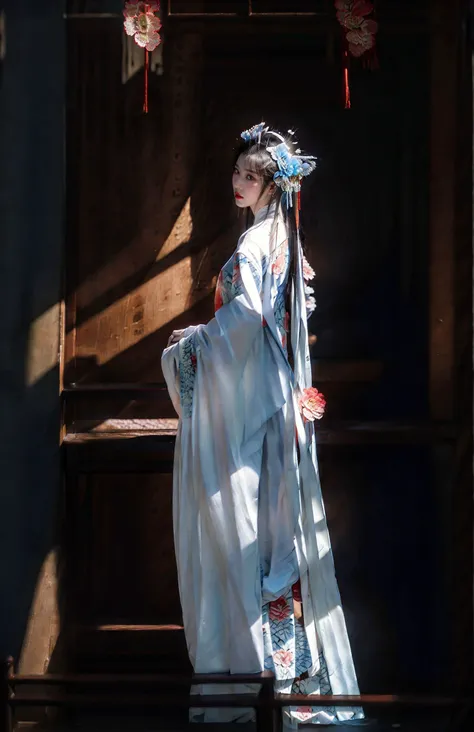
64 0 472 692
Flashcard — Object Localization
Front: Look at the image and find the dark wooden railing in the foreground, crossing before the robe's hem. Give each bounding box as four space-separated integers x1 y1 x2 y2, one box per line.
3 658 474 732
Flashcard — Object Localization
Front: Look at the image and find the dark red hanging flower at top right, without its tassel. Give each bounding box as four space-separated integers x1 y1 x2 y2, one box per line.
335 0 378 58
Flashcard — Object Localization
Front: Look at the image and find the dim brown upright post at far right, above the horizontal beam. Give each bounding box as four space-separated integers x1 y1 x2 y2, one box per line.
429 0 461 420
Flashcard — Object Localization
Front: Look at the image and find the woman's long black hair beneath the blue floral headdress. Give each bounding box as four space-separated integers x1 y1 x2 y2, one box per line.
234 133 299 367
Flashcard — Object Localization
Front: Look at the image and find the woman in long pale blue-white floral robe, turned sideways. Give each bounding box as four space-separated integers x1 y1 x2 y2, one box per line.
162 123 362 729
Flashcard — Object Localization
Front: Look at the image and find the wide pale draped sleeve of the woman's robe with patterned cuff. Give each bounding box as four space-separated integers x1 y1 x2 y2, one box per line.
162 237 285 445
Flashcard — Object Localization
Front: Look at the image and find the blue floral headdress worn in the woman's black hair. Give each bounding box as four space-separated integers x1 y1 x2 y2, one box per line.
240 122 317 207
